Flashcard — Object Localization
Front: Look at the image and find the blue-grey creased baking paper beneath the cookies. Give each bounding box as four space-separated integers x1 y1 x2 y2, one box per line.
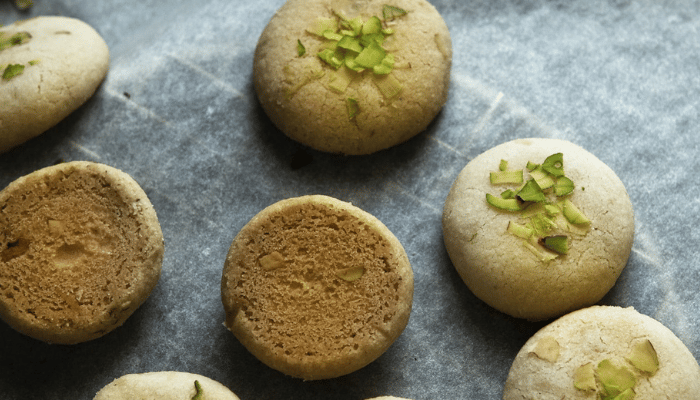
0 0 700 400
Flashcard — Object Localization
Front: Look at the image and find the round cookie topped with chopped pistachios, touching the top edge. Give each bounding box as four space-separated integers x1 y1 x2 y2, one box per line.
253 0 452 155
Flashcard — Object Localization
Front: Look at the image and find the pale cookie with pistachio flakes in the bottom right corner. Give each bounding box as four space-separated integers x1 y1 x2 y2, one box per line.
503 306 700 400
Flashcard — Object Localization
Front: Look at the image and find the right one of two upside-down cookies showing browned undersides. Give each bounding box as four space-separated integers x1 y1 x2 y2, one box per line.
221 195 413 380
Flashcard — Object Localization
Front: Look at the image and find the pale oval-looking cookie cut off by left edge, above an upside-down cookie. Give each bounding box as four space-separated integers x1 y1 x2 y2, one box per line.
0 16 109 153
